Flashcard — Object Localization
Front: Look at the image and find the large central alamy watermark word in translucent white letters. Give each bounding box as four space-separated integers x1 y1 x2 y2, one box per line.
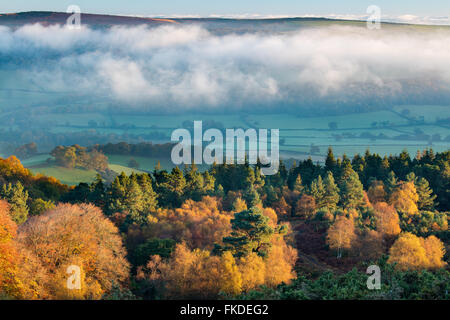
171 121 280 175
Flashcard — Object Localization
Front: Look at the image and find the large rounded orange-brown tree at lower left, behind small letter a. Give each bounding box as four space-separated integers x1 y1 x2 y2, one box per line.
18 204 128 299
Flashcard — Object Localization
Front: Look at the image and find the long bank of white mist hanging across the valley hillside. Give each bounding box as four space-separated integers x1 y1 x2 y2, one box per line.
0 23 450 110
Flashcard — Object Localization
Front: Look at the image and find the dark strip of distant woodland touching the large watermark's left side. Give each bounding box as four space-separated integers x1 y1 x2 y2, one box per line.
91 142 173 159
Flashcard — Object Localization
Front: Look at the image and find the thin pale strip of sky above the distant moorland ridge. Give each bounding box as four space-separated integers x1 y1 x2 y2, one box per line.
0 0 450 17
